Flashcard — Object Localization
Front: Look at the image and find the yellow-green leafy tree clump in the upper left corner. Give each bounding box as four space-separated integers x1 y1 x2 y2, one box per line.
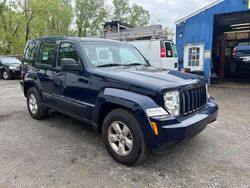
0 0 73 54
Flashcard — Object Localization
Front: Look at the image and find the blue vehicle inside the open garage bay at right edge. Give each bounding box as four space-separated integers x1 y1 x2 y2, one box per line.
233 41 250 63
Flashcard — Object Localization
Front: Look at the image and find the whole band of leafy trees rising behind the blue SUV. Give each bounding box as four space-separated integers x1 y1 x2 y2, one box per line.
0 0 150 55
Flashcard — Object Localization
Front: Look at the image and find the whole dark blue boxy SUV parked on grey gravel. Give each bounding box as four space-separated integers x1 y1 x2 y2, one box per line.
21 37 218 165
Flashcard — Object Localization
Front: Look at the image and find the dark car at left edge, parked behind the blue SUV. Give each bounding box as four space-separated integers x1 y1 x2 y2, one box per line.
0 57 22 80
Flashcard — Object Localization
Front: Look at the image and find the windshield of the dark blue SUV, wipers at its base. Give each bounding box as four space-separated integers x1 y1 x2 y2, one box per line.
82 42 149 67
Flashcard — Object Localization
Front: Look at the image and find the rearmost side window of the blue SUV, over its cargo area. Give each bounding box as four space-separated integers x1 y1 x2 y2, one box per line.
23 41 37 64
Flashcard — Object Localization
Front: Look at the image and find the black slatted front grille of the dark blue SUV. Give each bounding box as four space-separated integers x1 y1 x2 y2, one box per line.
180 85 207 115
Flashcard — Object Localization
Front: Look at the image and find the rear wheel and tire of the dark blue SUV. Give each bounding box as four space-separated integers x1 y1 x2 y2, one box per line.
27 87 48 120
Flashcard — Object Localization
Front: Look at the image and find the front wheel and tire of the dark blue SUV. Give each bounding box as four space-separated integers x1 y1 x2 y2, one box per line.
102 109 148 166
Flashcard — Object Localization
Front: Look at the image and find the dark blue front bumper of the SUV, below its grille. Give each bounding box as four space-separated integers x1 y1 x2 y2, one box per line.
151 99 218 152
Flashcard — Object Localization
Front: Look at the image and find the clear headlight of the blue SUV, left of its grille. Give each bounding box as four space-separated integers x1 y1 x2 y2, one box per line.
164 91 180 116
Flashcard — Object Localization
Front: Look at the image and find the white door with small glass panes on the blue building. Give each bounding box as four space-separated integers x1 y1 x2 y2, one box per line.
184 45 204 71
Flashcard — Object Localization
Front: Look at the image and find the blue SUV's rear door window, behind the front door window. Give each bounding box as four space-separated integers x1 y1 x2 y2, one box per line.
38 42 56 66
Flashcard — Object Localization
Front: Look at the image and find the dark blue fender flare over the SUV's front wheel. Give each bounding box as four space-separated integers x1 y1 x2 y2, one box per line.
92 88 159 147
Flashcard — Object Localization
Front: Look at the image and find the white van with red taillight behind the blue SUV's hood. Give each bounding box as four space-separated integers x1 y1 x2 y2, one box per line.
128 39 178 70
